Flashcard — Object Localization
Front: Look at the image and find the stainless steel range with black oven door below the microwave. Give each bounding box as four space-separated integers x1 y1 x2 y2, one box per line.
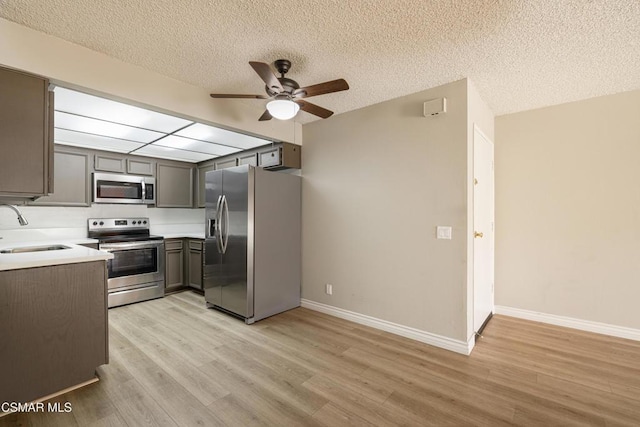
88 218 164 308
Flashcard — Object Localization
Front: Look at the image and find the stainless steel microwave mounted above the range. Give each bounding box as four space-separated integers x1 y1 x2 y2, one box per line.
93 173 156 205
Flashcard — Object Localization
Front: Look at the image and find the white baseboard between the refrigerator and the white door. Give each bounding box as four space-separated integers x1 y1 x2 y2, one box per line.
301 299 475 355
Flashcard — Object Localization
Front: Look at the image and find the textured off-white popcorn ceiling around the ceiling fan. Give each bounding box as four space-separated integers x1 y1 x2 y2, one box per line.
0 0 640 123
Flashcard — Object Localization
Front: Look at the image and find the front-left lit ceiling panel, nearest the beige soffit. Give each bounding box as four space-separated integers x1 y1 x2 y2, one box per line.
55 87 193 133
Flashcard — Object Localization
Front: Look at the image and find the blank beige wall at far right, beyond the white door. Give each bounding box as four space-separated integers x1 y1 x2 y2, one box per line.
495 91 640 329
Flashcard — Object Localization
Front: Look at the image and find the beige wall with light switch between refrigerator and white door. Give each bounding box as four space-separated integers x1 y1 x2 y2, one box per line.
302 80 468 342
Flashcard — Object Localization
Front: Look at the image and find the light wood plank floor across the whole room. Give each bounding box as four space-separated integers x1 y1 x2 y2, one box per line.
0 292 640 426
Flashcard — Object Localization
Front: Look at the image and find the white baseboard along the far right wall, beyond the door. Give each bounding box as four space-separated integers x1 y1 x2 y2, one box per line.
495 305 640 341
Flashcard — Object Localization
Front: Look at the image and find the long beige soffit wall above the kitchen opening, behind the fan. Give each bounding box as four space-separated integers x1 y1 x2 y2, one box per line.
0 18 302 144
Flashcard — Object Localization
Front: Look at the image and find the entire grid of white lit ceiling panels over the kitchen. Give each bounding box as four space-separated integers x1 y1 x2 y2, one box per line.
54 87 271 163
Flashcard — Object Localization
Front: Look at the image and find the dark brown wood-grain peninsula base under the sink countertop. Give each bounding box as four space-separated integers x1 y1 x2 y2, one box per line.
0 261 109 402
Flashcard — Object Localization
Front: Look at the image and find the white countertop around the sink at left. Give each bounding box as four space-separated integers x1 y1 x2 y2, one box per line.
0 239 113 271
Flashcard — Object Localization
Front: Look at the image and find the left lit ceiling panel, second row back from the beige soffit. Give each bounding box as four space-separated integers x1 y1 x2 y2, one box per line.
54 111 164 143
